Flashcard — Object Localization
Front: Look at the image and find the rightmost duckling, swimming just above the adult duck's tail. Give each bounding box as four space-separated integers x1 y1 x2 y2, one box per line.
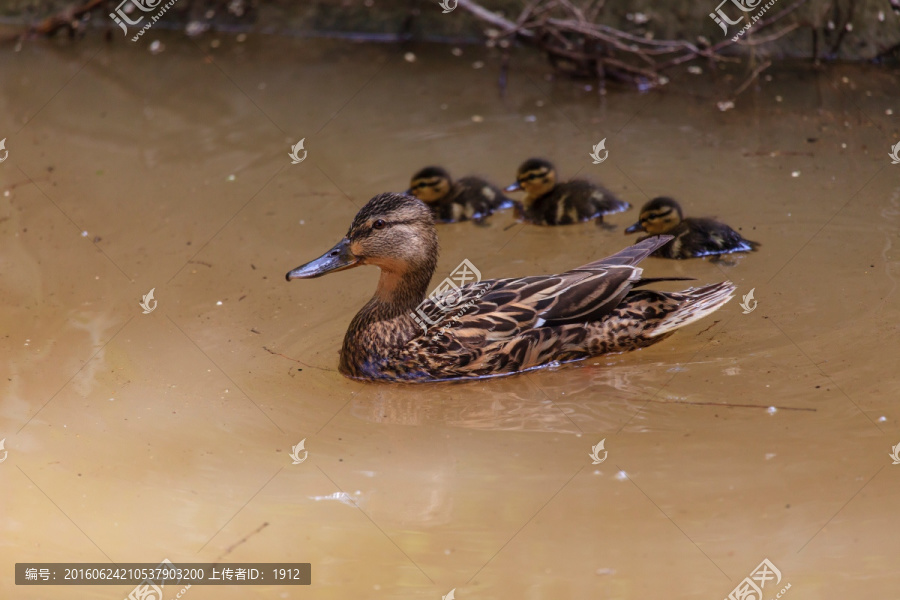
625 197 760 258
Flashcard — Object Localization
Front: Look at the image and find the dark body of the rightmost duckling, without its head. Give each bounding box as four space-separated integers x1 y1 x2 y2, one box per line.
641 218 759 259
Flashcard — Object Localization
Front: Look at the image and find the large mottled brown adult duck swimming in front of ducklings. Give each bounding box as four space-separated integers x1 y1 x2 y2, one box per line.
286 194 735 381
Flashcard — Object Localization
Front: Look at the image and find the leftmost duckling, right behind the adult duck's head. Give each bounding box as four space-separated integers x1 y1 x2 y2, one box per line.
406 167 513 223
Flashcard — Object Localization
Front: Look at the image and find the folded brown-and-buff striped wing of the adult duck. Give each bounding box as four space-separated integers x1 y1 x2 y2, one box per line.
440 236 671 346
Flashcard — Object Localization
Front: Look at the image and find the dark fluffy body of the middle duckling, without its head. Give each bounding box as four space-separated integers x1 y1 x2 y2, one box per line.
526 179 631 225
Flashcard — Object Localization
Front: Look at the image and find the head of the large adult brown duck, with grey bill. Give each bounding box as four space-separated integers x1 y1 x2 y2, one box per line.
286 193 438 292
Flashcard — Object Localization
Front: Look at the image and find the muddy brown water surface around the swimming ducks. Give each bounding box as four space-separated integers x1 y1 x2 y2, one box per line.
0 32 900 600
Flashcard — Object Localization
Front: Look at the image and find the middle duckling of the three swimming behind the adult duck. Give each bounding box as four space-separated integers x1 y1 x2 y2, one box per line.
504 158 631 225
